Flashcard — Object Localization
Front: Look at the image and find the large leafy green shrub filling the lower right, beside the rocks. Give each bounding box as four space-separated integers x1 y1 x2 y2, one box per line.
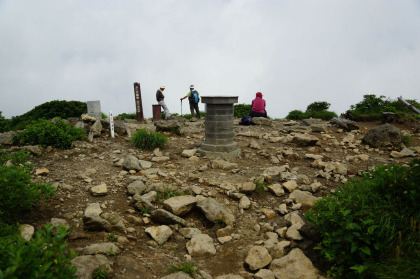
306 159 420 278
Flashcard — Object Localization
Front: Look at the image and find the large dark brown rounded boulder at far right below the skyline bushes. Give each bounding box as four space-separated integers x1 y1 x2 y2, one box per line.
362 124 402 147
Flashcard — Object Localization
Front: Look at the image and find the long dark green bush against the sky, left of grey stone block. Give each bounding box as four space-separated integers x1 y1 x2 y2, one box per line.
10 100 87 130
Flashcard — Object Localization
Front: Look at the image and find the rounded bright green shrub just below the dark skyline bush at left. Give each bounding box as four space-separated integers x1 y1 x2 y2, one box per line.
13 119 86 149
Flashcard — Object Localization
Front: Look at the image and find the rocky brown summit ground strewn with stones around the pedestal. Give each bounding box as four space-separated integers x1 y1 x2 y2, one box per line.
5 119 420 278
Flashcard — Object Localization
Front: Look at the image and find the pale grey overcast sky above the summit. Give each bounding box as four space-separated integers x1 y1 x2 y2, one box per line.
0 0 420 118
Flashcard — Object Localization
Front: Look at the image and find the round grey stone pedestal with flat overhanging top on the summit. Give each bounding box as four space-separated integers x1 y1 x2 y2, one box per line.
200 96 241 159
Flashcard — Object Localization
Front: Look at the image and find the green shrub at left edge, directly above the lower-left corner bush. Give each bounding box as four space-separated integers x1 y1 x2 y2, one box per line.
0 165 55 220
